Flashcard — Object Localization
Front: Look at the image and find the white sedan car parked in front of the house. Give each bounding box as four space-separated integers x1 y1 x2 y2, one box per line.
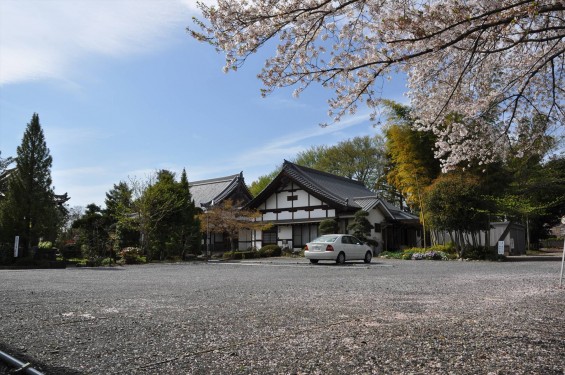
304 234 373 264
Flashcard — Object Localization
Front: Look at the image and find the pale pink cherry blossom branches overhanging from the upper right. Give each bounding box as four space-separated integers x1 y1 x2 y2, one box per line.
189 0 565 168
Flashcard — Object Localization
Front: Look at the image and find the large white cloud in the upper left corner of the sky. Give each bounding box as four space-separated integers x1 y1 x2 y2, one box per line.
0 0 196 85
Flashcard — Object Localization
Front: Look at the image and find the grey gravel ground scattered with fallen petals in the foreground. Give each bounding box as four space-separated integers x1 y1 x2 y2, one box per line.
0 258 565 375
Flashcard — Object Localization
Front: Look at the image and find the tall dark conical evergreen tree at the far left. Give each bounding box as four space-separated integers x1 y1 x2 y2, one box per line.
1 113 61 249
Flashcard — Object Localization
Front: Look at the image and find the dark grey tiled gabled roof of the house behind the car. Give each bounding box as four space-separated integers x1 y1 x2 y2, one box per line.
248 160 373 209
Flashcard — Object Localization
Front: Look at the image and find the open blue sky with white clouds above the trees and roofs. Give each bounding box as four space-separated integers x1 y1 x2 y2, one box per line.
0 0 406 207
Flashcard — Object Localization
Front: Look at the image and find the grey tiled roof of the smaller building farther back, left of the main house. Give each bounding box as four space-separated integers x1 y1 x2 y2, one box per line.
188 172 252 207
